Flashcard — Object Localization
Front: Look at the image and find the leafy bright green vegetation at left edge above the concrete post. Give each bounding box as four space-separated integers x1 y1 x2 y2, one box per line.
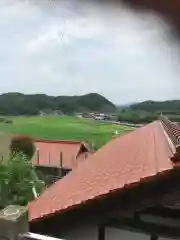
0 153 45 207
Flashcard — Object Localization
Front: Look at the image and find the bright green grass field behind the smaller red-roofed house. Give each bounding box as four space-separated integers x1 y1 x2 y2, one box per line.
0 116 131 149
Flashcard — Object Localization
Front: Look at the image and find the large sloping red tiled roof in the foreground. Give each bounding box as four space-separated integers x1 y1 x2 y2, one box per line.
28 121 177 221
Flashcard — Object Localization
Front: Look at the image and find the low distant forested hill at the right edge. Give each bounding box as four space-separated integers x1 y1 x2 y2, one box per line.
130 100 180 113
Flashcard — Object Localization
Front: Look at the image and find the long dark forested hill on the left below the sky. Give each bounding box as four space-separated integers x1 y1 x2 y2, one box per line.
0 93 116 115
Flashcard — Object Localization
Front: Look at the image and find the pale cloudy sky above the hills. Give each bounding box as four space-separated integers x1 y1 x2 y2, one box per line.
0 0 180 104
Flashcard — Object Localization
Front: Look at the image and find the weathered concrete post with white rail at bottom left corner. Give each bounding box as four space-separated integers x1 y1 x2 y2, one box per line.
0 205 64 240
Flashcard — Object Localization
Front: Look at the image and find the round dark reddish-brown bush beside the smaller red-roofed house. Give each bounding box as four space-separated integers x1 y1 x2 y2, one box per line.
10 135 35 159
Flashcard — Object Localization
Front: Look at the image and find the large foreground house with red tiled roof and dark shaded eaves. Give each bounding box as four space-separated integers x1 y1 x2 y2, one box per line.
28 117 180 240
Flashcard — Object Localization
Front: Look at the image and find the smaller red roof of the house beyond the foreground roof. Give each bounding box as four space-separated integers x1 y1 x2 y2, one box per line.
32 140 88 169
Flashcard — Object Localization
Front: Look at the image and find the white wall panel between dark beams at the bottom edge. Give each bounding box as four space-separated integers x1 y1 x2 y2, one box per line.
105 228 150 240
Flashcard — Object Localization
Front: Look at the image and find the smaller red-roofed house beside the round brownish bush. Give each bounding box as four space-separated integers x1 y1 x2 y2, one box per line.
32 140 91 186
